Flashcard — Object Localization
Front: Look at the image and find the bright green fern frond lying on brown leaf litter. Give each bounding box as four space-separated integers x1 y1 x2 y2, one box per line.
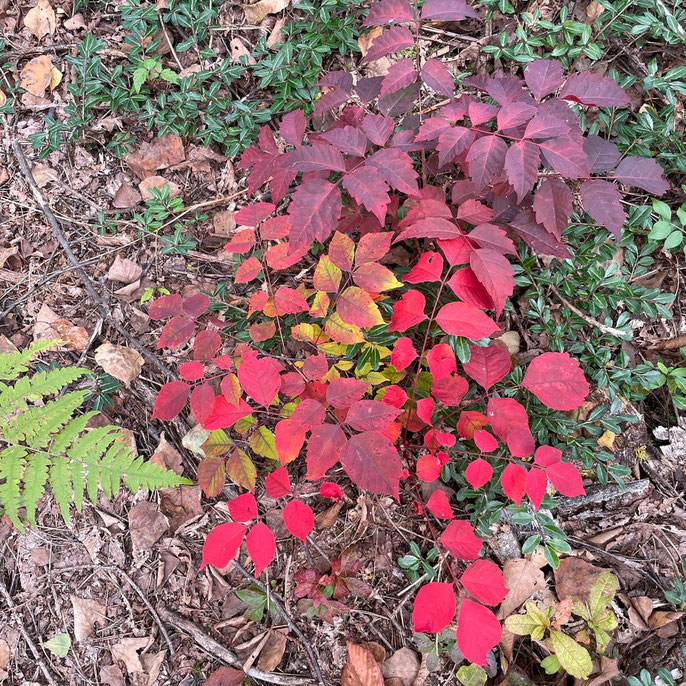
0 341 190 529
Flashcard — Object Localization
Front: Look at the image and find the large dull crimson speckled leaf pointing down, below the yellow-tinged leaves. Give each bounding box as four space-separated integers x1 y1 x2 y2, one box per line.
340 431 402 500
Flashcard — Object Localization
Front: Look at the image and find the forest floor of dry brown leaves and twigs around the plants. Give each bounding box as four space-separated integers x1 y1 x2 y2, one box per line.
0 0 686 686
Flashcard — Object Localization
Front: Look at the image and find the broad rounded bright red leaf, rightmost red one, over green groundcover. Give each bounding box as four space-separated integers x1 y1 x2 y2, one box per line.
522 353 590 410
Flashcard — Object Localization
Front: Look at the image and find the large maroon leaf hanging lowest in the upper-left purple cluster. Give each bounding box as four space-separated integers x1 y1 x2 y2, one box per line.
288 179 342 253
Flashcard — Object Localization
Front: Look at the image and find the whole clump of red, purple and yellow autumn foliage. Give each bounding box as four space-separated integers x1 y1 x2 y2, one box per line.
150 0 667 664
